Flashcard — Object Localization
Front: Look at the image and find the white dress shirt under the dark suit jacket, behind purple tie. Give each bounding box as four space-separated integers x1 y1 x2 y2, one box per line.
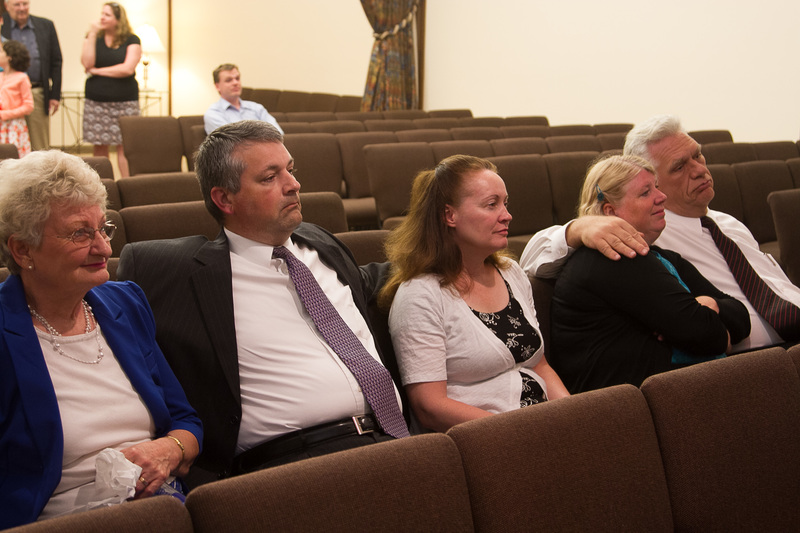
225 229 400 453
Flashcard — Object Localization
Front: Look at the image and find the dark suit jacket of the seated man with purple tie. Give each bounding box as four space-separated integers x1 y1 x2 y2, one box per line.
117 223 398 486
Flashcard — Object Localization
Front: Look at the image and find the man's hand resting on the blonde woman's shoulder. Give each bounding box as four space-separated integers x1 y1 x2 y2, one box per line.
567 216 650 261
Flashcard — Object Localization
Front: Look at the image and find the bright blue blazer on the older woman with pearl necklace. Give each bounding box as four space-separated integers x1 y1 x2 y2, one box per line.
0 276 203 529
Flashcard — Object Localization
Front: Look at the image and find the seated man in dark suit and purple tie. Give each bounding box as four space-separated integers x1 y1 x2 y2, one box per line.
117 120 408 485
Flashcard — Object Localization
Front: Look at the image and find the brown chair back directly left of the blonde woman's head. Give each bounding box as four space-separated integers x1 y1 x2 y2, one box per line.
542 152 597 224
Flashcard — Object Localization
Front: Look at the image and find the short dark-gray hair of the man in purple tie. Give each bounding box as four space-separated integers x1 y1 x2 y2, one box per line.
195 120 283 224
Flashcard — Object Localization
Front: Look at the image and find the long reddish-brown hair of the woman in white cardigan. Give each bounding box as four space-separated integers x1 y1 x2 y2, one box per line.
378 155 508 310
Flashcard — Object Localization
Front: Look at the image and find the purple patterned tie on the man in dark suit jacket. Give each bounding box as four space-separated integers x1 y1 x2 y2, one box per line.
272 246 408 439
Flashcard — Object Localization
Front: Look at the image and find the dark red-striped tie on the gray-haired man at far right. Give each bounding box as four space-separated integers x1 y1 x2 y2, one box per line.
700 217 800 341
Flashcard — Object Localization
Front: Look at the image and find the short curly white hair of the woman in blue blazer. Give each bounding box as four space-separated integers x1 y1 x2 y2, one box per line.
0 150 108 274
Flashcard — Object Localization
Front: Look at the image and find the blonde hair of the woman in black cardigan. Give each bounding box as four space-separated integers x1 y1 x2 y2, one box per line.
578 155 656 217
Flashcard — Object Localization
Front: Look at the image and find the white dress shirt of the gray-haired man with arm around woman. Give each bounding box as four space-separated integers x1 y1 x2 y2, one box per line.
520 210 800 353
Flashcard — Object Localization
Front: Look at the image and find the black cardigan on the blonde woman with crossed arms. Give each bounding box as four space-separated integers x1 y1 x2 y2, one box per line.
548 246 750 393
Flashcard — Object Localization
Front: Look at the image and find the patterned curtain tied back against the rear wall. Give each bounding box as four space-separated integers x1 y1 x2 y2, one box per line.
361 0 419 111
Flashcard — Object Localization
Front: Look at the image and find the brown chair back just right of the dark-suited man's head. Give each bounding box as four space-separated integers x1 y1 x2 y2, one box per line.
283 133 344 195
